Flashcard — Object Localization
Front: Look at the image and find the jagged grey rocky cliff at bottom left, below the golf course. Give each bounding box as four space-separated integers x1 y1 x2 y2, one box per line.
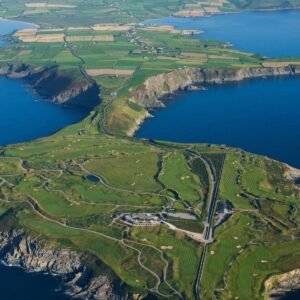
0 231 127 300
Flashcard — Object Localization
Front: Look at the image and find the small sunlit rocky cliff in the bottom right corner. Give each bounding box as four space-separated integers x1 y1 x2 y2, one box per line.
265 269 300 300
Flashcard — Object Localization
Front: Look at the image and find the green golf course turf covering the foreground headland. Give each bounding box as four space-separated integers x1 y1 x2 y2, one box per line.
0 134 299 299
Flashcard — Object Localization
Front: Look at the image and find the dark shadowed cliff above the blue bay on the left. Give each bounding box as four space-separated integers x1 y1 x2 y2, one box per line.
0 64 100 108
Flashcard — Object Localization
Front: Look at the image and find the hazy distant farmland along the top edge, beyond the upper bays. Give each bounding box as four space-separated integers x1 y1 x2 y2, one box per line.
0 0 300 27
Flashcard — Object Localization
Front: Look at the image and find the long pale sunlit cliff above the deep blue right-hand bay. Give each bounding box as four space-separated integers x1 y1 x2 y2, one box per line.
131 66 300 108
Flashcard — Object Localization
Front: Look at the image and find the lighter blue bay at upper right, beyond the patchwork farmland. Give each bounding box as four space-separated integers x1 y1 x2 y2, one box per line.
147 10 300 57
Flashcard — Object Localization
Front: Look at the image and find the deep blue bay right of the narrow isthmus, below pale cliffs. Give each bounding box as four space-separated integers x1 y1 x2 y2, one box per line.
136 78 300 167
